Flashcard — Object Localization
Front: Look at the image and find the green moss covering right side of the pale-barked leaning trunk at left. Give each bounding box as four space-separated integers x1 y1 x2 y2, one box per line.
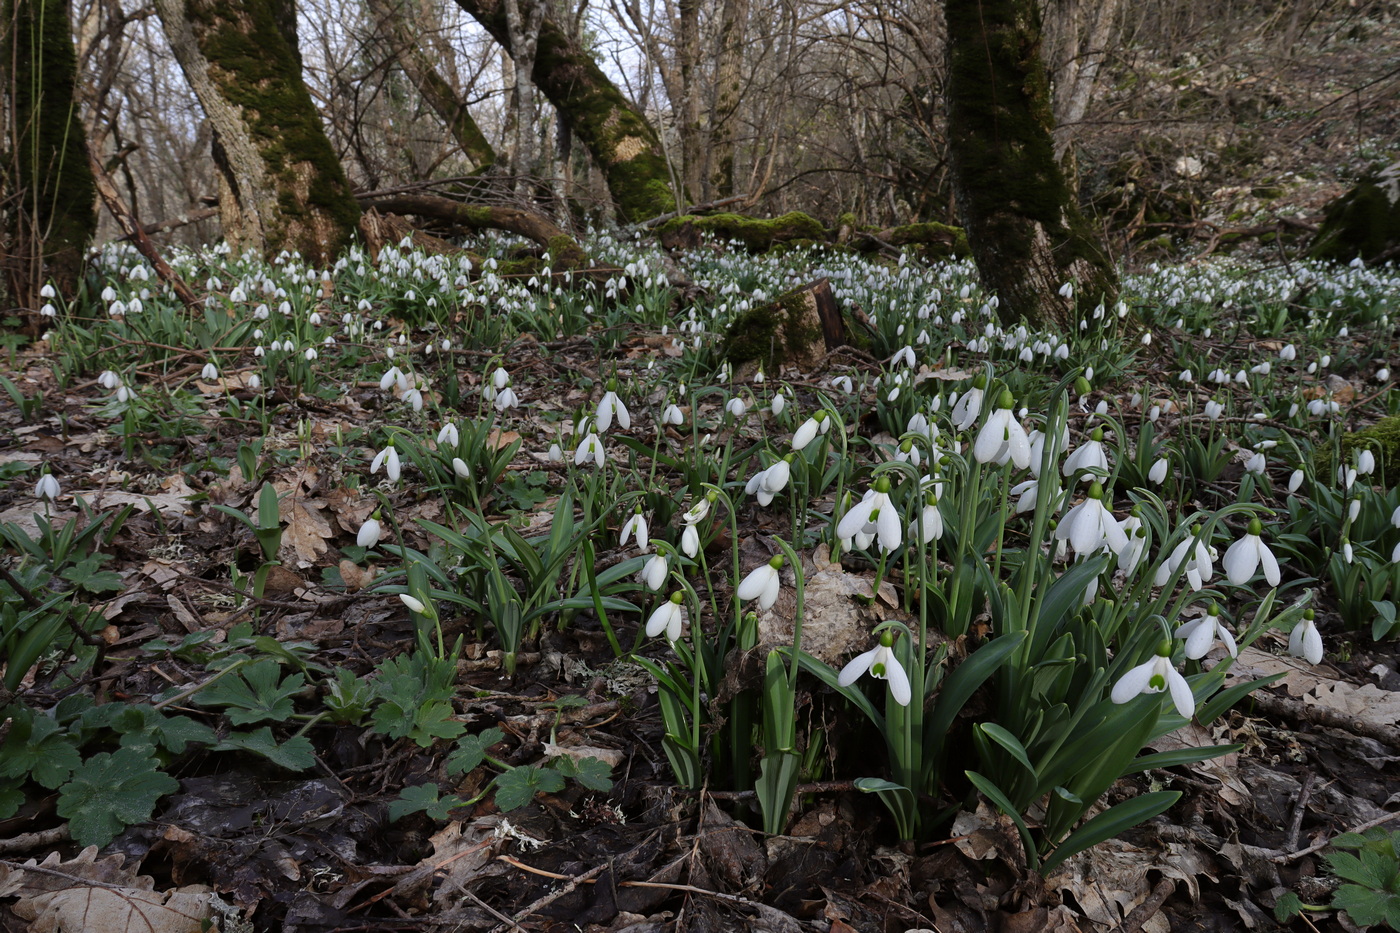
185 0 360 262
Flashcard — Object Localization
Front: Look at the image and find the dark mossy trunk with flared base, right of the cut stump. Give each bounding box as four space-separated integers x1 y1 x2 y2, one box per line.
944 0 1117 325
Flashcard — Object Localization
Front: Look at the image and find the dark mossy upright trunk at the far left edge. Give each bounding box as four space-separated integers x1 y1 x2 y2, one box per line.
0 0 97 301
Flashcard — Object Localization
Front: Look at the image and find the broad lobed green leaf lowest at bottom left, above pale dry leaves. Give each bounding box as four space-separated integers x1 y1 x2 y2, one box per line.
59 748 179 846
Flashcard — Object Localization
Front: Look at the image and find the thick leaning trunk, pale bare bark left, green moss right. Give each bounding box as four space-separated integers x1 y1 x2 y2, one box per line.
155 0 360 265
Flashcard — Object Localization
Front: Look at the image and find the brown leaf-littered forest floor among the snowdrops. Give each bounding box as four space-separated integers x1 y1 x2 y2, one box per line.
0 218 1400 933
